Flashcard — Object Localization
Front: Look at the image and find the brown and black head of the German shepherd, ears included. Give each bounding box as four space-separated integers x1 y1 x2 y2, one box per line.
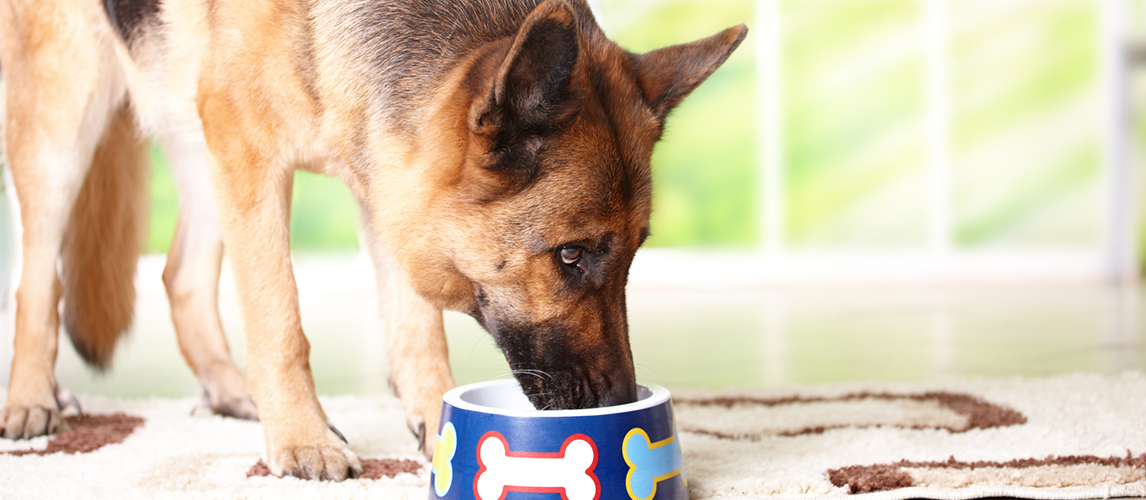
406 0 747 409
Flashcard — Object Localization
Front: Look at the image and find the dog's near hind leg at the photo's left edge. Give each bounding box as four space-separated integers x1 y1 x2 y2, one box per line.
0 0 126 438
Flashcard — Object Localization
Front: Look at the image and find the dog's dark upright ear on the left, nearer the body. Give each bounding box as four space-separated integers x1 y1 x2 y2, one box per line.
469 0 581 135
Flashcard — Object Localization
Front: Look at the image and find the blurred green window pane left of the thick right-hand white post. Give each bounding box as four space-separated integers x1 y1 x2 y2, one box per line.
951 0 1104 248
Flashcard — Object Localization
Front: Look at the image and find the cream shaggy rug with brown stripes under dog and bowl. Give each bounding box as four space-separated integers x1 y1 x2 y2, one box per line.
0 373 1146 500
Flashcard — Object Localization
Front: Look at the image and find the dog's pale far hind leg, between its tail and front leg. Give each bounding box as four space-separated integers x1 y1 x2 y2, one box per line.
162 131 258 420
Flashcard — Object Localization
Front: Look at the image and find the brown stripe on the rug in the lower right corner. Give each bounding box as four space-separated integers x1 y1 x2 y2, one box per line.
827 451 1146 494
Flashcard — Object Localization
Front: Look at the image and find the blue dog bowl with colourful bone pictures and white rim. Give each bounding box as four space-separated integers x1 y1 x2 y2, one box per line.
430 380 689 500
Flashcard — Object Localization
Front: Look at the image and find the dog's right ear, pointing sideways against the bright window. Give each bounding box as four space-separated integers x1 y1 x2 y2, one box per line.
634 24 748 119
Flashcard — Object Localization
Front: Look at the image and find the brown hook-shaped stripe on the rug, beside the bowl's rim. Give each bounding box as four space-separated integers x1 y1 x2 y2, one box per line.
673 391 1027 440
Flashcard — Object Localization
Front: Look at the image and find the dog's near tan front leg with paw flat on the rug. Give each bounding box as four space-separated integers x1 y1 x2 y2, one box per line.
204 146 362 481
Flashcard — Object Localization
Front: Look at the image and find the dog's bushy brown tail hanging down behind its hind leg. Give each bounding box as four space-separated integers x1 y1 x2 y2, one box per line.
61 103 150 370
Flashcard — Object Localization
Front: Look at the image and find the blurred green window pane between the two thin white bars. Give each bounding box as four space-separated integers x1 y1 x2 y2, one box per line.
780 0 927 248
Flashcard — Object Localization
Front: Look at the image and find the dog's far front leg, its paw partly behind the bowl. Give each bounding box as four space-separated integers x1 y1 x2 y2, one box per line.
360 208 454 459
